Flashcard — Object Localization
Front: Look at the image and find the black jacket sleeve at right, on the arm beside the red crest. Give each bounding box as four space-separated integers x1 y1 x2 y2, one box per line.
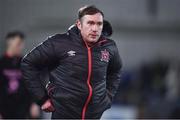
106 42 122 101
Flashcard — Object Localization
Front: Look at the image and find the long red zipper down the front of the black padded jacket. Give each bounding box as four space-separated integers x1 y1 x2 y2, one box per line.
81 44 92 120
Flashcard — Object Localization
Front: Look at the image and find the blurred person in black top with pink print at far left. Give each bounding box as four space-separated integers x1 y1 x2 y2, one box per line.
0 31 38 119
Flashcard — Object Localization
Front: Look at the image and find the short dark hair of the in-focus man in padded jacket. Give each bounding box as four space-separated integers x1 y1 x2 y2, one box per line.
78 5 104 19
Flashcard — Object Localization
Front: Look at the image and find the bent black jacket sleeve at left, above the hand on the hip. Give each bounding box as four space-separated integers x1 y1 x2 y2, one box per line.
21 38 56 105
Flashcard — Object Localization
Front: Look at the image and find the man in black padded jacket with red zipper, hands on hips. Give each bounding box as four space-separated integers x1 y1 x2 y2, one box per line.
22 6 121 120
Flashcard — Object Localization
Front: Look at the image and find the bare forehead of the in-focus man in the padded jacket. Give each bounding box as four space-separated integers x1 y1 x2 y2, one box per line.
83 13 103 22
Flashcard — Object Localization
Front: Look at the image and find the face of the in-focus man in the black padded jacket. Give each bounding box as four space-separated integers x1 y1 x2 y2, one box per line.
77 13 103 43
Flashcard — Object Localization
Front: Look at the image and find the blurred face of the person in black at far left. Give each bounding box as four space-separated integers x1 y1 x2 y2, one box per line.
8 36 24 55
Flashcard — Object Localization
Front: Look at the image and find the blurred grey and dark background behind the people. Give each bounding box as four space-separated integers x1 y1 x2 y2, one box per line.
0 0 180 119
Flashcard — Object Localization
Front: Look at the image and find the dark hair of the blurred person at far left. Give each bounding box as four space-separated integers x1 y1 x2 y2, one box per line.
5 31 25 40
